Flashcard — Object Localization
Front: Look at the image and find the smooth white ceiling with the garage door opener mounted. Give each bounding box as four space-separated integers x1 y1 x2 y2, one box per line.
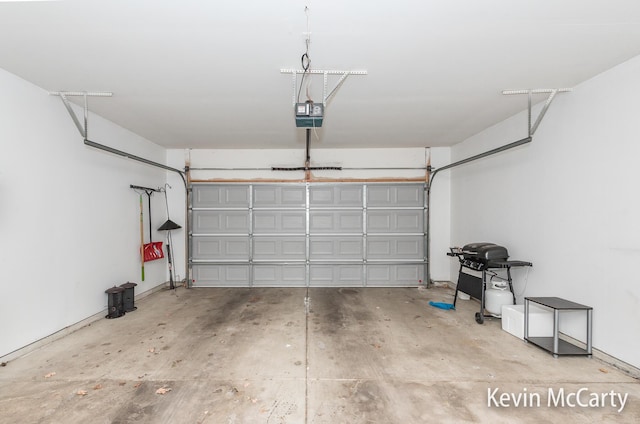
0 0 640 148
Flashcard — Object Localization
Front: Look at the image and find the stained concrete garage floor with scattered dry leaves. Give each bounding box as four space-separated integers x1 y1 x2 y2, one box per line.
0 288 640 424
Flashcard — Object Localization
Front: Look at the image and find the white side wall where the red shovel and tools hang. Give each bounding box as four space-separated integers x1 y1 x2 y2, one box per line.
0 70 166 357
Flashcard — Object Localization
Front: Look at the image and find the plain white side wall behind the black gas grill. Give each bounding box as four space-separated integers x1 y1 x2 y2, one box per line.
451 57 640 367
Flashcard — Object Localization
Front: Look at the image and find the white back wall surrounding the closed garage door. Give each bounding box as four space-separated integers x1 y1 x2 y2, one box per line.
167 146 451 281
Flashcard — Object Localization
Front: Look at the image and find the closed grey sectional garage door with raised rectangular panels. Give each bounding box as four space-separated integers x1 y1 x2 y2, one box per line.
189 183 426 287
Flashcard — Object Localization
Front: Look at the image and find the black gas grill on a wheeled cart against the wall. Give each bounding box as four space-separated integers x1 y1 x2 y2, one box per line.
447 243 533 324
